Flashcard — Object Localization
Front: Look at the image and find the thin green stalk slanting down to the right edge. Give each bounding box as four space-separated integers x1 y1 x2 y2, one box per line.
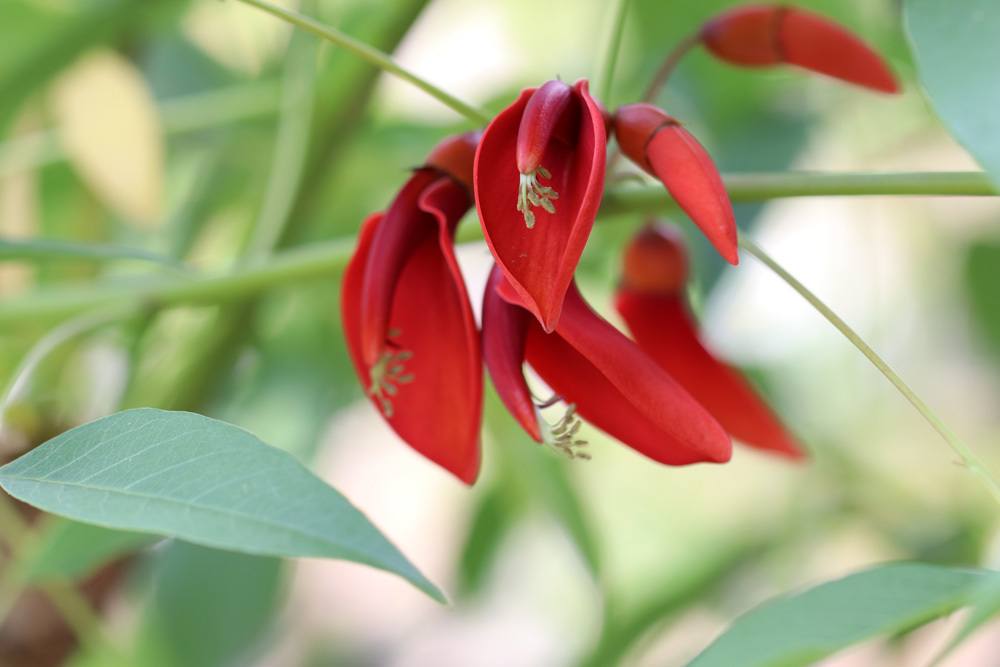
740 238 1000 503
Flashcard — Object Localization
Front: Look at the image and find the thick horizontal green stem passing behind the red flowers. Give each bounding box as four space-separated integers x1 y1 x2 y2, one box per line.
0 172 996 330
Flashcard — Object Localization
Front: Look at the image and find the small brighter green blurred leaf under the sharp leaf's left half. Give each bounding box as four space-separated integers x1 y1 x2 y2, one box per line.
20 518 157 583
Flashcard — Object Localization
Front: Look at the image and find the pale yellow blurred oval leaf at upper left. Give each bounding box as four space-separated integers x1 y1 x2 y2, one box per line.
53 51 164 227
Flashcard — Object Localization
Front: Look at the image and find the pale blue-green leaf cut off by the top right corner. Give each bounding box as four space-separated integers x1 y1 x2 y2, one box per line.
905 0 1000 184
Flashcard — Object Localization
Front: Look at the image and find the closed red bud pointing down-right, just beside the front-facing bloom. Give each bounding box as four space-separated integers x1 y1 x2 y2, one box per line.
614 104 739 264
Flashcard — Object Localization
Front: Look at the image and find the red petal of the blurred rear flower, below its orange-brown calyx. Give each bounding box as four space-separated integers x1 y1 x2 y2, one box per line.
615 289 804 458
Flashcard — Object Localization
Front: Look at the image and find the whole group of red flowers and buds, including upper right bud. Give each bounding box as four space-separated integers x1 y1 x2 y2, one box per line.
341 5 897 484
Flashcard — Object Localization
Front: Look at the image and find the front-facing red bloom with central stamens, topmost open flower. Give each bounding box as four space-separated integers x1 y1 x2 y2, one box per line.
474 81 607 331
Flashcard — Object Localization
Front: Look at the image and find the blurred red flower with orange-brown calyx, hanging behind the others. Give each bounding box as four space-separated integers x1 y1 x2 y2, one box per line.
615 226 803 458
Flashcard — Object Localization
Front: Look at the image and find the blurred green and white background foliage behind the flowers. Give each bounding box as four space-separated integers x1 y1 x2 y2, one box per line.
0 0 1000 666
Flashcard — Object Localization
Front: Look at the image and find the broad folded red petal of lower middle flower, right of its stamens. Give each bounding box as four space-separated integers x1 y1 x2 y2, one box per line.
526 286 732 465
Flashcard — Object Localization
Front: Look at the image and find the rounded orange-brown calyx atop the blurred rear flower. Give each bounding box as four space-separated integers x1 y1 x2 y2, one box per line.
622 223 688 295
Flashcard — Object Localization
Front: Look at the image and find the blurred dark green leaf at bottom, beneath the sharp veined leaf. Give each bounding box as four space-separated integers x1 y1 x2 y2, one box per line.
132 542 282 667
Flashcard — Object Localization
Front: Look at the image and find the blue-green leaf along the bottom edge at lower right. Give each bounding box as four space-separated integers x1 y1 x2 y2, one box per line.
689 563 988 667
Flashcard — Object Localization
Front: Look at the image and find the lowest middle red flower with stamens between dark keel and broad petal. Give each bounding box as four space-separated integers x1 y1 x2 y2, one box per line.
483 267 732 465
